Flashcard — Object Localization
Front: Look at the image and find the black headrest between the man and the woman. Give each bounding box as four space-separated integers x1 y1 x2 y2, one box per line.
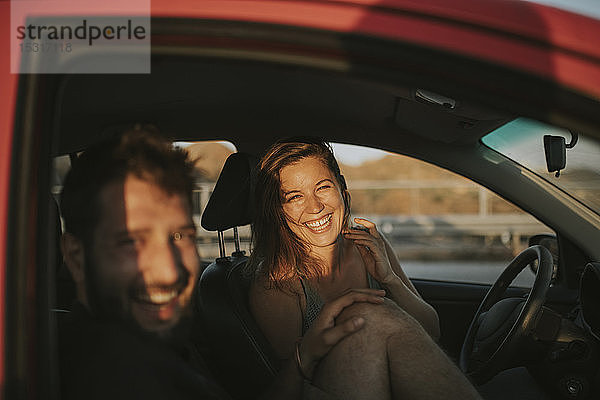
201 153 256 231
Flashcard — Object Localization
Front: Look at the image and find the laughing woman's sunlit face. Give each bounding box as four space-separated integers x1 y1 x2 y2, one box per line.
279 157 344 247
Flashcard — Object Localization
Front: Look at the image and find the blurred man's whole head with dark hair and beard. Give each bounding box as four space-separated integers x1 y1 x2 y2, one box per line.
61 128 200 338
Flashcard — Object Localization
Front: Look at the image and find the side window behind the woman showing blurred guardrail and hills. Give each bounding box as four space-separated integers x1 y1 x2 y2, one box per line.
333 144 552 287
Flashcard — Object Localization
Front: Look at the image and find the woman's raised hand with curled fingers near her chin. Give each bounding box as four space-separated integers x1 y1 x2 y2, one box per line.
344 218 398 285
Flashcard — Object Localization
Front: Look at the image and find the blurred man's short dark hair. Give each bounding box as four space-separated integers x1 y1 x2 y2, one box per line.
61 127 194 246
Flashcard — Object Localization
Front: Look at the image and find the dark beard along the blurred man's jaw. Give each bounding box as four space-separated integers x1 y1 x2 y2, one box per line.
85 252 197 347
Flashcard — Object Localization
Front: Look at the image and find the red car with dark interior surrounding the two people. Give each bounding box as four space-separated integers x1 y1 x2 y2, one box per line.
0 0 600 400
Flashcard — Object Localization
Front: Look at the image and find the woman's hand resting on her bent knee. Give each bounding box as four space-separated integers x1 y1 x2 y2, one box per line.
297 289 385 378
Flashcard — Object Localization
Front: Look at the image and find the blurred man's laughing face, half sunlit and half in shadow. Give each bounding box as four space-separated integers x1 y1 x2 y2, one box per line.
64 174 199 337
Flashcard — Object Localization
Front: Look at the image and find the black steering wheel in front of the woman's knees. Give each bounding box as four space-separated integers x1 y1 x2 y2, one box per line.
459 245 553 384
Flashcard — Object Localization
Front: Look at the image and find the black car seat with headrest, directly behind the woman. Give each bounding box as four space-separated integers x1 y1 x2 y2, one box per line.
195 153 278 399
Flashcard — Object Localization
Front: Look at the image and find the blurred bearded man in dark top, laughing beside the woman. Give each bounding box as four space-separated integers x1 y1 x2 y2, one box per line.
60 130 232 399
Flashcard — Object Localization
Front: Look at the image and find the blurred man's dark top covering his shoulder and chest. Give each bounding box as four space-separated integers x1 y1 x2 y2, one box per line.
59 304 230 399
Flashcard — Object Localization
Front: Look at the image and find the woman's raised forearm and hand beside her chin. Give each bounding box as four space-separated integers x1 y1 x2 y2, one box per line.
344 218 440 340
